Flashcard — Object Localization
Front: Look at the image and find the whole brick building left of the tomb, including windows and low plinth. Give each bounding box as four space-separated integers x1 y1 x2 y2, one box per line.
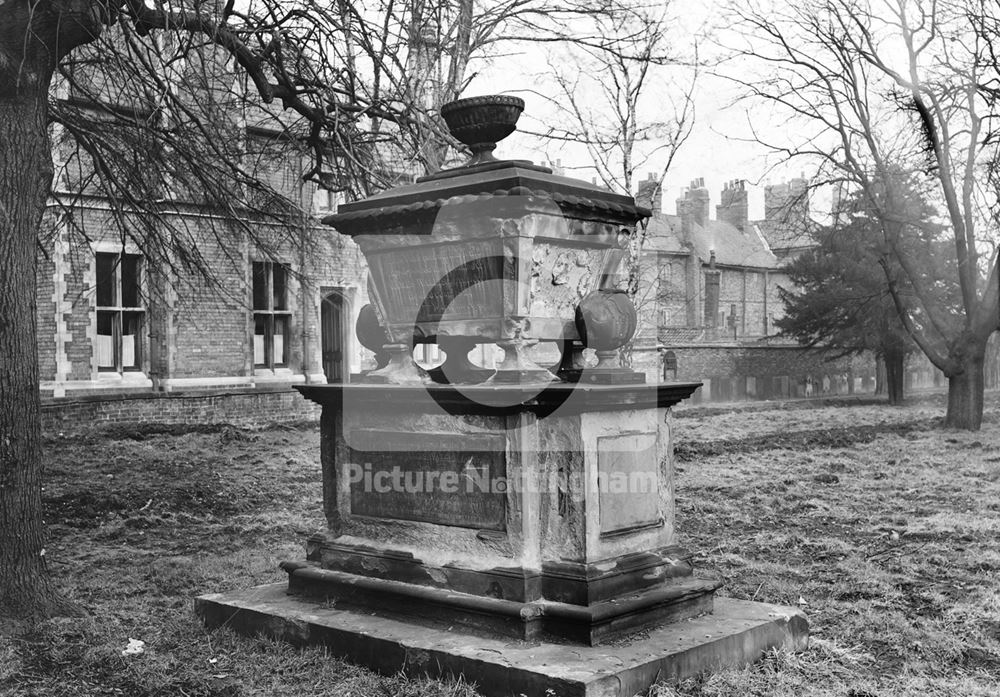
37 66 367 430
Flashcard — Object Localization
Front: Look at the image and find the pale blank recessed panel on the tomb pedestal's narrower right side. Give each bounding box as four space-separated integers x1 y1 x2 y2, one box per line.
597 433 663 535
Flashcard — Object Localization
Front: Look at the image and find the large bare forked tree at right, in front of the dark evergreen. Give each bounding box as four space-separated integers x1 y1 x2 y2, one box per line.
729 0 1000 430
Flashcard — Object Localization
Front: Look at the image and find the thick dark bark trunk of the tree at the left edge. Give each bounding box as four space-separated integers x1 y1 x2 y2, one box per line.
0 88 58 618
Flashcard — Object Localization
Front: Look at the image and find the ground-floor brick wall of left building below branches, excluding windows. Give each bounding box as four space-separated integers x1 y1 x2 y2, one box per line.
36 201 367 397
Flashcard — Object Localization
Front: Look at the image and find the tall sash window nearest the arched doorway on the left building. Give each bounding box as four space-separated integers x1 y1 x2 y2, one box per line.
253 261 292 370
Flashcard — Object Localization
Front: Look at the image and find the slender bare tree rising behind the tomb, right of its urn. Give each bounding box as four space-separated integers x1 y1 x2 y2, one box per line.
533 2 699 365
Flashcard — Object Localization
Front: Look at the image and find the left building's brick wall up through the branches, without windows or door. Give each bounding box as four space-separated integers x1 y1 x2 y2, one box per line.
36 51 376 419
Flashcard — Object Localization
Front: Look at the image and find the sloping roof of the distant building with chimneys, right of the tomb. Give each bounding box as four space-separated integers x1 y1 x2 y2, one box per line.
645 213 780 269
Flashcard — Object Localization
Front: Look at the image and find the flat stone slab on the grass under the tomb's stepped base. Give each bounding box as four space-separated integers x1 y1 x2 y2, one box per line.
195 583 809 697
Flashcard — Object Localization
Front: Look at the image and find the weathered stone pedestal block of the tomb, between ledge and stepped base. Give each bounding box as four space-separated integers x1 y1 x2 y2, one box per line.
309 385 683 605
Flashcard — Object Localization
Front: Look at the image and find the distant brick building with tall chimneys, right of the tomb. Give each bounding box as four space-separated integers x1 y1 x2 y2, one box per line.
633 178 884 401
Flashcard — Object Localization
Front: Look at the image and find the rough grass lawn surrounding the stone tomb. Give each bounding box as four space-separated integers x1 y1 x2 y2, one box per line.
0 395 1000 697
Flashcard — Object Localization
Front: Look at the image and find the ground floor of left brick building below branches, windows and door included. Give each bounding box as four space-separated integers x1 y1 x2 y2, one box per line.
37 201 367 430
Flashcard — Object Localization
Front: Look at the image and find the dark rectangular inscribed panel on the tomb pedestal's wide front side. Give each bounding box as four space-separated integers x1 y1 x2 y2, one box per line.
346 429 507 531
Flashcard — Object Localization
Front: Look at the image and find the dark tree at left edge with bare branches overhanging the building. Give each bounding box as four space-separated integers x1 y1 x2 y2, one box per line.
0 0 672 618
